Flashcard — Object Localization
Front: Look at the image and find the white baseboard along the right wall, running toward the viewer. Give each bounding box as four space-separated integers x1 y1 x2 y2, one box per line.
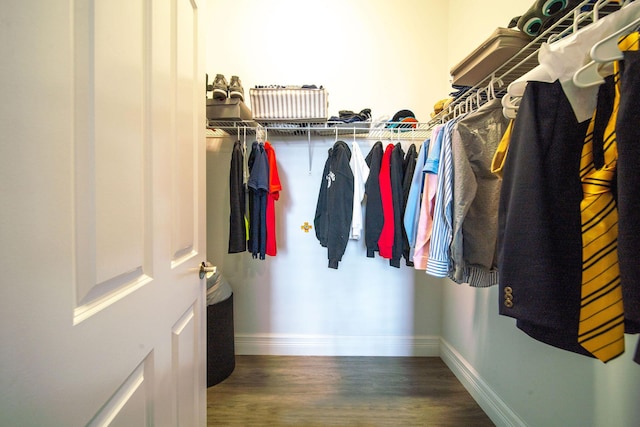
440 340 527 427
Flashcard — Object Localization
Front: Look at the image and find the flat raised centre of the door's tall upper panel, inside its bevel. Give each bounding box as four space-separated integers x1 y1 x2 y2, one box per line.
94 0 146 289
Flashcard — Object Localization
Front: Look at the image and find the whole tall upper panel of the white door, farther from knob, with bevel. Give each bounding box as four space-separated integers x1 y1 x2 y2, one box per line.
72 0 152 323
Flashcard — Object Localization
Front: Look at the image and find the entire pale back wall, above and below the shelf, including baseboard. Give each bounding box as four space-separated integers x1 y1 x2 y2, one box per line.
207 0 449 355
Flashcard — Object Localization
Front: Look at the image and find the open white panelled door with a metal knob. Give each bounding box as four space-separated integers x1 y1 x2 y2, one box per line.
0 0 206 427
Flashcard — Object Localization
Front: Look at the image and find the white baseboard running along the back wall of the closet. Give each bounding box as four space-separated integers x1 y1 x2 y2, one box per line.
235 334 440 357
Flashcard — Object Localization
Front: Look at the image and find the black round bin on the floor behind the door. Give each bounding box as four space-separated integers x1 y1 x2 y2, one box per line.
207 293 236 387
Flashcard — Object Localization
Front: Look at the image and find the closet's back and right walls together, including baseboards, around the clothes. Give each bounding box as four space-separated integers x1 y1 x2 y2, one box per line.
207 0 640 427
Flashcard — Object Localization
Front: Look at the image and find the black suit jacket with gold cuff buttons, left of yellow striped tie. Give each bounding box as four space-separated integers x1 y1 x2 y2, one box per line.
498 81 590 355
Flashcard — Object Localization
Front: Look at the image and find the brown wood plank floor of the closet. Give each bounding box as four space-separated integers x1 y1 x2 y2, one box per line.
207 356 494 427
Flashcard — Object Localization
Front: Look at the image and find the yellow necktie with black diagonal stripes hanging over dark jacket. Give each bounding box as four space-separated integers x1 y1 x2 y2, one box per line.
578 62 624 362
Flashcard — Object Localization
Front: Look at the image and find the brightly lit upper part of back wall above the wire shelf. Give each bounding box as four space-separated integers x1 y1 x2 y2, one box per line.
207 0 449 120
